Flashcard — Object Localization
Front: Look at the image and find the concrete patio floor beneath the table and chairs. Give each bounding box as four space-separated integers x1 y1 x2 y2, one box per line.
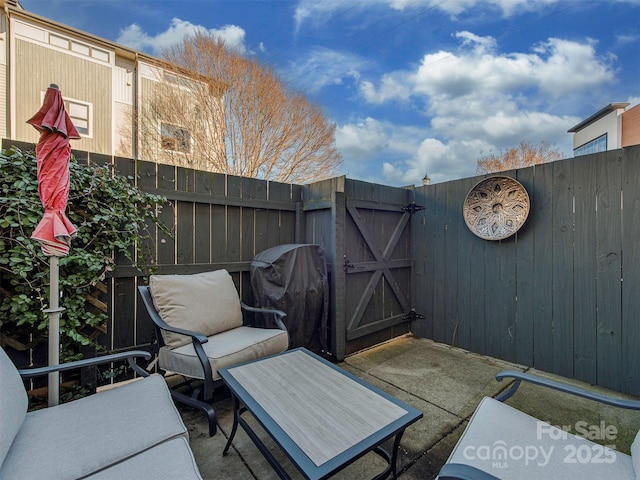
179 335 640 480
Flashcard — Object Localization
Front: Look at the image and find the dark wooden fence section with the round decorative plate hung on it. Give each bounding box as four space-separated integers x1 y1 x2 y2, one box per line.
413 146 640 395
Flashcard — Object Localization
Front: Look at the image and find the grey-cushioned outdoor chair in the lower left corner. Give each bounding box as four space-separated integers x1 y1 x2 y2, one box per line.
0 347 202 480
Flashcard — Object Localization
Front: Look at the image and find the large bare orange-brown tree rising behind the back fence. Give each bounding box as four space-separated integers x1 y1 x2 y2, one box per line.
133 33 342 183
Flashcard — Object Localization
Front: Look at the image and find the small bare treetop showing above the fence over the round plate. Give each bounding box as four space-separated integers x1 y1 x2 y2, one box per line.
476 141 564 174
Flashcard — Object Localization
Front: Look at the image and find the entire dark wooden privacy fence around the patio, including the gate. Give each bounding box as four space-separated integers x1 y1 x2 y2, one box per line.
4 140 640 395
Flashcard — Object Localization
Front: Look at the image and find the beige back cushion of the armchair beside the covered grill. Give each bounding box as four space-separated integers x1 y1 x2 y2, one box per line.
149 270 242 348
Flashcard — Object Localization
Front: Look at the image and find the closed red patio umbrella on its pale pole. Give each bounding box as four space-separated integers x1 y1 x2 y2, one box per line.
27 84 80 405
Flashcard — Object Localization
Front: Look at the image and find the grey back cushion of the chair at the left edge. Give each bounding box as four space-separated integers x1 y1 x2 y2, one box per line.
0 348 29 468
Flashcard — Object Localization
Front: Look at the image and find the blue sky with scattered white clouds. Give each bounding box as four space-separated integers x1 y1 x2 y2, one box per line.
21 0 640 186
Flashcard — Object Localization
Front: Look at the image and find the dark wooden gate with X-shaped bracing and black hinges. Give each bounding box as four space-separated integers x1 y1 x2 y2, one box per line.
334 180 422 359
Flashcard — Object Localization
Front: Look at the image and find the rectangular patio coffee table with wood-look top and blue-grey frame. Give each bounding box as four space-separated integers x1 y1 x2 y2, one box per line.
219 348 422 479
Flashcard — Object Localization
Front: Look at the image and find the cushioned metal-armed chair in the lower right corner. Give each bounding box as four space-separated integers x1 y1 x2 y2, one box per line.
438 371 640 480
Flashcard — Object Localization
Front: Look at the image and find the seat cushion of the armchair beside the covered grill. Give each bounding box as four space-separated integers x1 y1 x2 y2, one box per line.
158 327 289 380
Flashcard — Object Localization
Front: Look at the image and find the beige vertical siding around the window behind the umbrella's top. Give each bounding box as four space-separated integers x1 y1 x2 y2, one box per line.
14 39 113 154
